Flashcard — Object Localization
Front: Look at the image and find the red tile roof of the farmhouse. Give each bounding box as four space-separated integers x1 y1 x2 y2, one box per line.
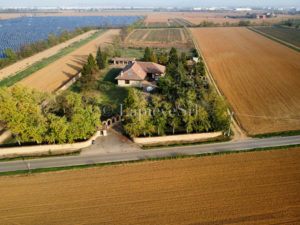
115 62 166 80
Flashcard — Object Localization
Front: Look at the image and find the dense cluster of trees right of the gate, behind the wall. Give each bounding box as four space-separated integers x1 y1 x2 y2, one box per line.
124 48 230 136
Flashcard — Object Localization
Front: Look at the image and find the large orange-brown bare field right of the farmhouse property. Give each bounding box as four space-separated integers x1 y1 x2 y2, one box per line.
191 28 300 135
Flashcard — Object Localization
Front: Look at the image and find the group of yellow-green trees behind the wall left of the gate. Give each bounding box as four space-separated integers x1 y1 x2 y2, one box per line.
0 85 101 144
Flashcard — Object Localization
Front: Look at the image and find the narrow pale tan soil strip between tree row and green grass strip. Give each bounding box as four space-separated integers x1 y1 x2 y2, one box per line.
0 31 95 80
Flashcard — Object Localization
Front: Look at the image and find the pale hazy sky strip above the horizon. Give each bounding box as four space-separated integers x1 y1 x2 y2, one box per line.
0 0 300 7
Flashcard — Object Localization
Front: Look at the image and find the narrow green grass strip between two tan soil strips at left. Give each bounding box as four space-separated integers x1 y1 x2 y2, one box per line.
0 30 105 87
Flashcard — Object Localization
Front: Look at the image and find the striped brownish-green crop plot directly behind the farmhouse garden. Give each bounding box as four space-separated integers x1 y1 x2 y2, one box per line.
125 28 191 47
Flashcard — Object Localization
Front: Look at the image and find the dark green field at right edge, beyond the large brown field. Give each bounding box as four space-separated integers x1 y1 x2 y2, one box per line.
255 26 300 47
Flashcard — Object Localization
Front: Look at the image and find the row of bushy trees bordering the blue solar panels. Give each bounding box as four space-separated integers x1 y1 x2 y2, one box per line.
0 27 93 69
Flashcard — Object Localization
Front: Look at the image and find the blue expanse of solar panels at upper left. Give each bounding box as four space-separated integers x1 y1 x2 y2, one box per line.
0 16 139 57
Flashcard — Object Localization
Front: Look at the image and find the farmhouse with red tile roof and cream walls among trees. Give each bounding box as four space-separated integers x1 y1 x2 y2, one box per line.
115 62 166 87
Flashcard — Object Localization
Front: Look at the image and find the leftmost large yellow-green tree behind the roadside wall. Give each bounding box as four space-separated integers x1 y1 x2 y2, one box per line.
0 85 47 144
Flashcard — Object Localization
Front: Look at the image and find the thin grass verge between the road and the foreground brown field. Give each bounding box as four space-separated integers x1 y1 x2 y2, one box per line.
0 144 300 176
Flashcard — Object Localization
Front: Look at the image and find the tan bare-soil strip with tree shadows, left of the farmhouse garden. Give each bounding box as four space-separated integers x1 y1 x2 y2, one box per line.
20 29 120 91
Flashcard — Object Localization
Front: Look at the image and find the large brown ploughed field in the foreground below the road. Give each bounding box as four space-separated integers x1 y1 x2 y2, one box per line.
0 148 300 225
